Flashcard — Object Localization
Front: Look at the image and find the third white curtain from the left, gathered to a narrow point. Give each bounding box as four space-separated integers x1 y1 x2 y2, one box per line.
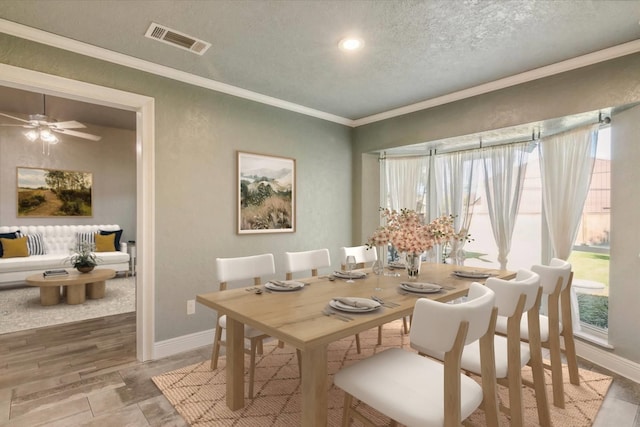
482 143 529 269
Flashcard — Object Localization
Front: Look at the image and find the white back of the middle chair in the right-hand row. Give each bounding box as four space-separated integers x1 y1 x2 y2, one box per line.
485 270 540 321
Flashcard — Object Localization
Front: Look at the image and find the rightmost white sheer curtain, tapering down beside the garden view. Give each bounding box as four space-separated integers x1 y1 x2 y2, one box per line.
538 124 598 260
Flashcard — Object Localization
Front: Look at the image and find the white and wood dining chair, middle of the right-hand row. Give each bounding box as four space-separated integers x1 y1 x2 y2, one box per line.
425 270 551 427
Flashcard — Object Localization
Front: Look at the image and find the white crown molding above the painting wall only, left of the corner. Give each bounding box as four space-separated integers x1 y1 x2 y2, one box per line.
0 18 353 126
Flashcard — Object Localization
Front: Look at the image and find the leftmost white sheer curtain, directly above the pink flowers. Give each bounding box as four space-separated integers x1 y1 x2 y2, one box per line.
385 156 429 214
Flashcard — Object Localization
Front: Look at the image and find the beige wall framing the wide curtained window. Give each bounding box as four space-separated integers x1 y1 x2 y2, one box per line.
353 54 640 362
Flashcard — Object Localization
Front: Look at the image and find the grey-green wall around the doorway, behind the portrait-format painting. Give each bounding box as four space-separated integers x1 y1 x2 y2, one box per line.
0 34 352 342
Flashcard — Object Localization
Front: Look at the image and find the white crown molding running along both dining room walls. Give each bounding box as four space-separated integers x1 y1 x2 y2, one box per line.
0 18 640 128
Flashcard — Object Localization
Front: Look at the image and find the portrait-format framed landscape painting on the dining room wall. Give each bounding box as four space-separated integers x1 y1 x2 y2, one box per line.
238 151 296 234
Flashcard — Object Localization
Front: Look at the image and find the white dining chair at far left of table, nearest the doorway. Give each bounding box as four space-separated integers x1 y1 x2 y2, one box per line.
211 254 276 399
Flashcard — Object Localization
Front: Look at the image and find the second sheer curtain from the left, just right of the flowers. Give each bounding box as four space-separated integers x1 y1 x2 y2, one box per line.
435 150 479 262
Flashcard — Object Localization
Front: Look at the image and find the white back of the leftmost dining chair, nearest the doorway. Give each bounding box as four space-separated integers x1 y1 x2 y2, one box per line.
216 254 276 289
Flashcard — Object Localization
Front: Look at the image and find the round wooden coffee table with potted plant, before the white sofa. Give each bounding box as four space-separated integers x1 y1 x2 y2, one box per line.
25 268 116 305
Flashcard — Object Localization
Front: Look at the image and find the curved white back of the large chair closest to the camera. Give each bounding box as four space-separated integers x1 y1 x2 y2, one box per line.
409 282 495 353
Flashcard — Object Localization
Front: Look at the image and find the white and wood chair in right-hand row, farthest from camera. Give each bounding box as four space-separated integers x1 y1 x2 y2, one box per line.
496 258 580 408
